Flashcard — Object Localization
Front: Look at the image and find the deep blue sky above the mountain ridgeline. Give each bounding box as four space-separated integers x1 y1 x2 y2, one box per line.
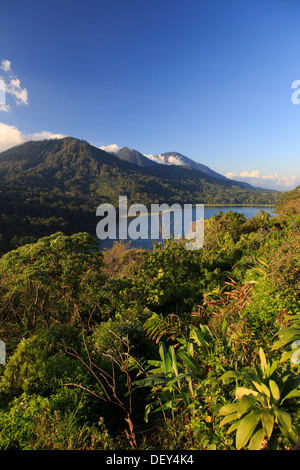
0 0 300 190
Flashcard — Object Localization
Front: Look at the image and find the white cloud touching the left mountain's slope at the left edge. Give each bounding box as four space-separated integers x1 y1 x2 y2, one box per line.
0 122 65 152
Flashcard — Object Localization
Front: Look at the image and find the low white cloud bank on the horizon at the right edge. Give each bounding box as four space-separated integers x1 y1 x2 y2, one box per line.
225 170 300 191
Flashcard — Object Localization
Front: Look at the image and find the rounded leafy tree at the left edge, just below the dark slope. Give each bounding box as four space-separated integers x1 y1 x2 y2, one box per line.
0 232 104 331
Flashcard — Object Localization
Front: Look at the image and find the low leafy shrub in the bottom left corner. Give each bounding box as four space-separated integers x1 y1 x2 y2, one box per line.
0 394 114 450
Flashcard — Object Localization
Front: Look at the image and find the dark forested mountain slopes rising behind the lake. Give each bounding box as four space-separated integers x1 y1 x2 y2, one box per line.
0 137 279 253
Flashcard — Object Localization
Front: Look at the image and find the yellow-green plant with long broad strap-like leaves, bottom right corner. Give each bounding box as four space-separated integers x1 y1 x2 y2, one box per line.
219 349 300 450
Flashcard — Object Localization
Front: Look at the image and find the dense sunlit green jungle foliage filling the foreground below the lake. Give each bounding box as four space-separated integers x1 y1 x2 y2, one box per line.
0 187 300 450
